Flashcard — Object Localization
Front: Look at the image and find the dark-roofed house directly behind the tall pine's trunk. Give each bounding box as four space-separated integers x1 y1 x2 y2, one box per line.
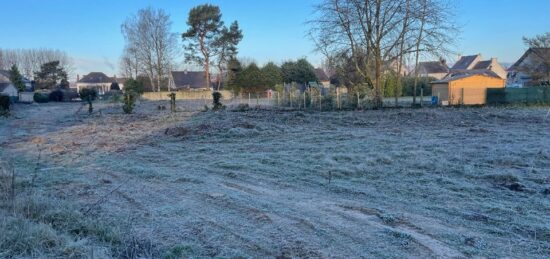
170 71 214 91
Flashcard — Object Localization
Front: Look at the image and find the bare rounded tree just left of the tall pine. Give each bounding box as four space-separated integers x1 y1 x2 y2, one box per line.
122 7 177 91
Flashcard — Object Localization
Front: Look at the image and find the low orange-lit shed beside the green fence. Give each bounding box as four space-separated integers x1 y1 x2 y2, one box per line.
431 69 506 105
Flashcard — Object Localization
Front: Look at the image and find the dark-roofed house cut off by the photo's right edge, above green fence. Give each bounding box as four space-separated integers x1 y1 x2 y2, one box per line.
506 48 550 87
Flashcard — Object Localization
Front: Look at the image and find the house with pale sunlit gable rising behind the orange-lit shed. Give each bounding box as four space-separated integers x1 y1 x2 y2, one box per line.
450 54 508 79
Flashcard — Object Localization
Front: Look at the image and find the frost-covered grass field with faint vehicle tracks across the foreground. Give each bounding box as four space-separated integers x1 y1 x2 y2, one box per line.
0 103 550 258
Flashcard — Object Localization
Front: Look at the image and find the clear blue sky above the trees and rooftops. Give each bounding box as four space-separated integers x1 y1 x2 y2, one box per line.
0 0 550 77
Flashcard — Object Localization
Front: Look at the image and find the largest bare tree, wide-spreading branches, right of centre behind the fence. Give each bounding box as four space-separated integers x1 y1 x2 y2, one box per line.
310 0 460 107
